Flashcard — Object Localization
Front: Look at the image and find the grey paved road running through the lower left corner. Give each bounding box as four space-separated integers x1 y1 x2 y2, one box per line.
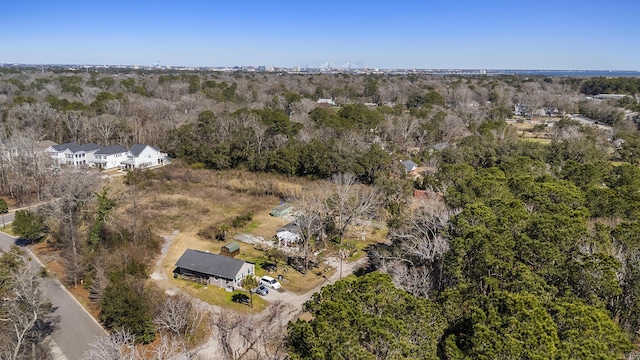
0 231 106 360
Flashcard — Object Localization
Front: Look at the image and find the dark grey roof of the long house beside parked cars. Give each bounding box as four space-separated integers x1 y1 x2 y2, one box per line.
176 249 246 279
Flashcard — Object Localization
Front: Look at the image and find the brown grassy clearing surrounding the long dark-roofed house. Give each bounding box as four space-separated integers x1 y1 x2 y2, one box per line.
130 167 386 304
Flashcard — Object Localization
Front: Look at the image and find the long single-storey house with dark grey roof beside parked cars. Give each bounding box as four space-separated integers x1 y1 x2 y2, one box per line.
173 249 255 289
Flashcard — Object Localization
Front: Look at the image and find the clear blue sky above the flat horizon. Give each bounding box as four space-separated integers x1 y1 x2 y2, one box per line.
0 0 640 70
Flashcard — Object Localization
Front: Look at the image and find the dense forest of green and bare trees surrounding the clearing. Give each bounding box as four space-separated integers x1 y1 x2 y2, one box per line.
0 69 640 359
